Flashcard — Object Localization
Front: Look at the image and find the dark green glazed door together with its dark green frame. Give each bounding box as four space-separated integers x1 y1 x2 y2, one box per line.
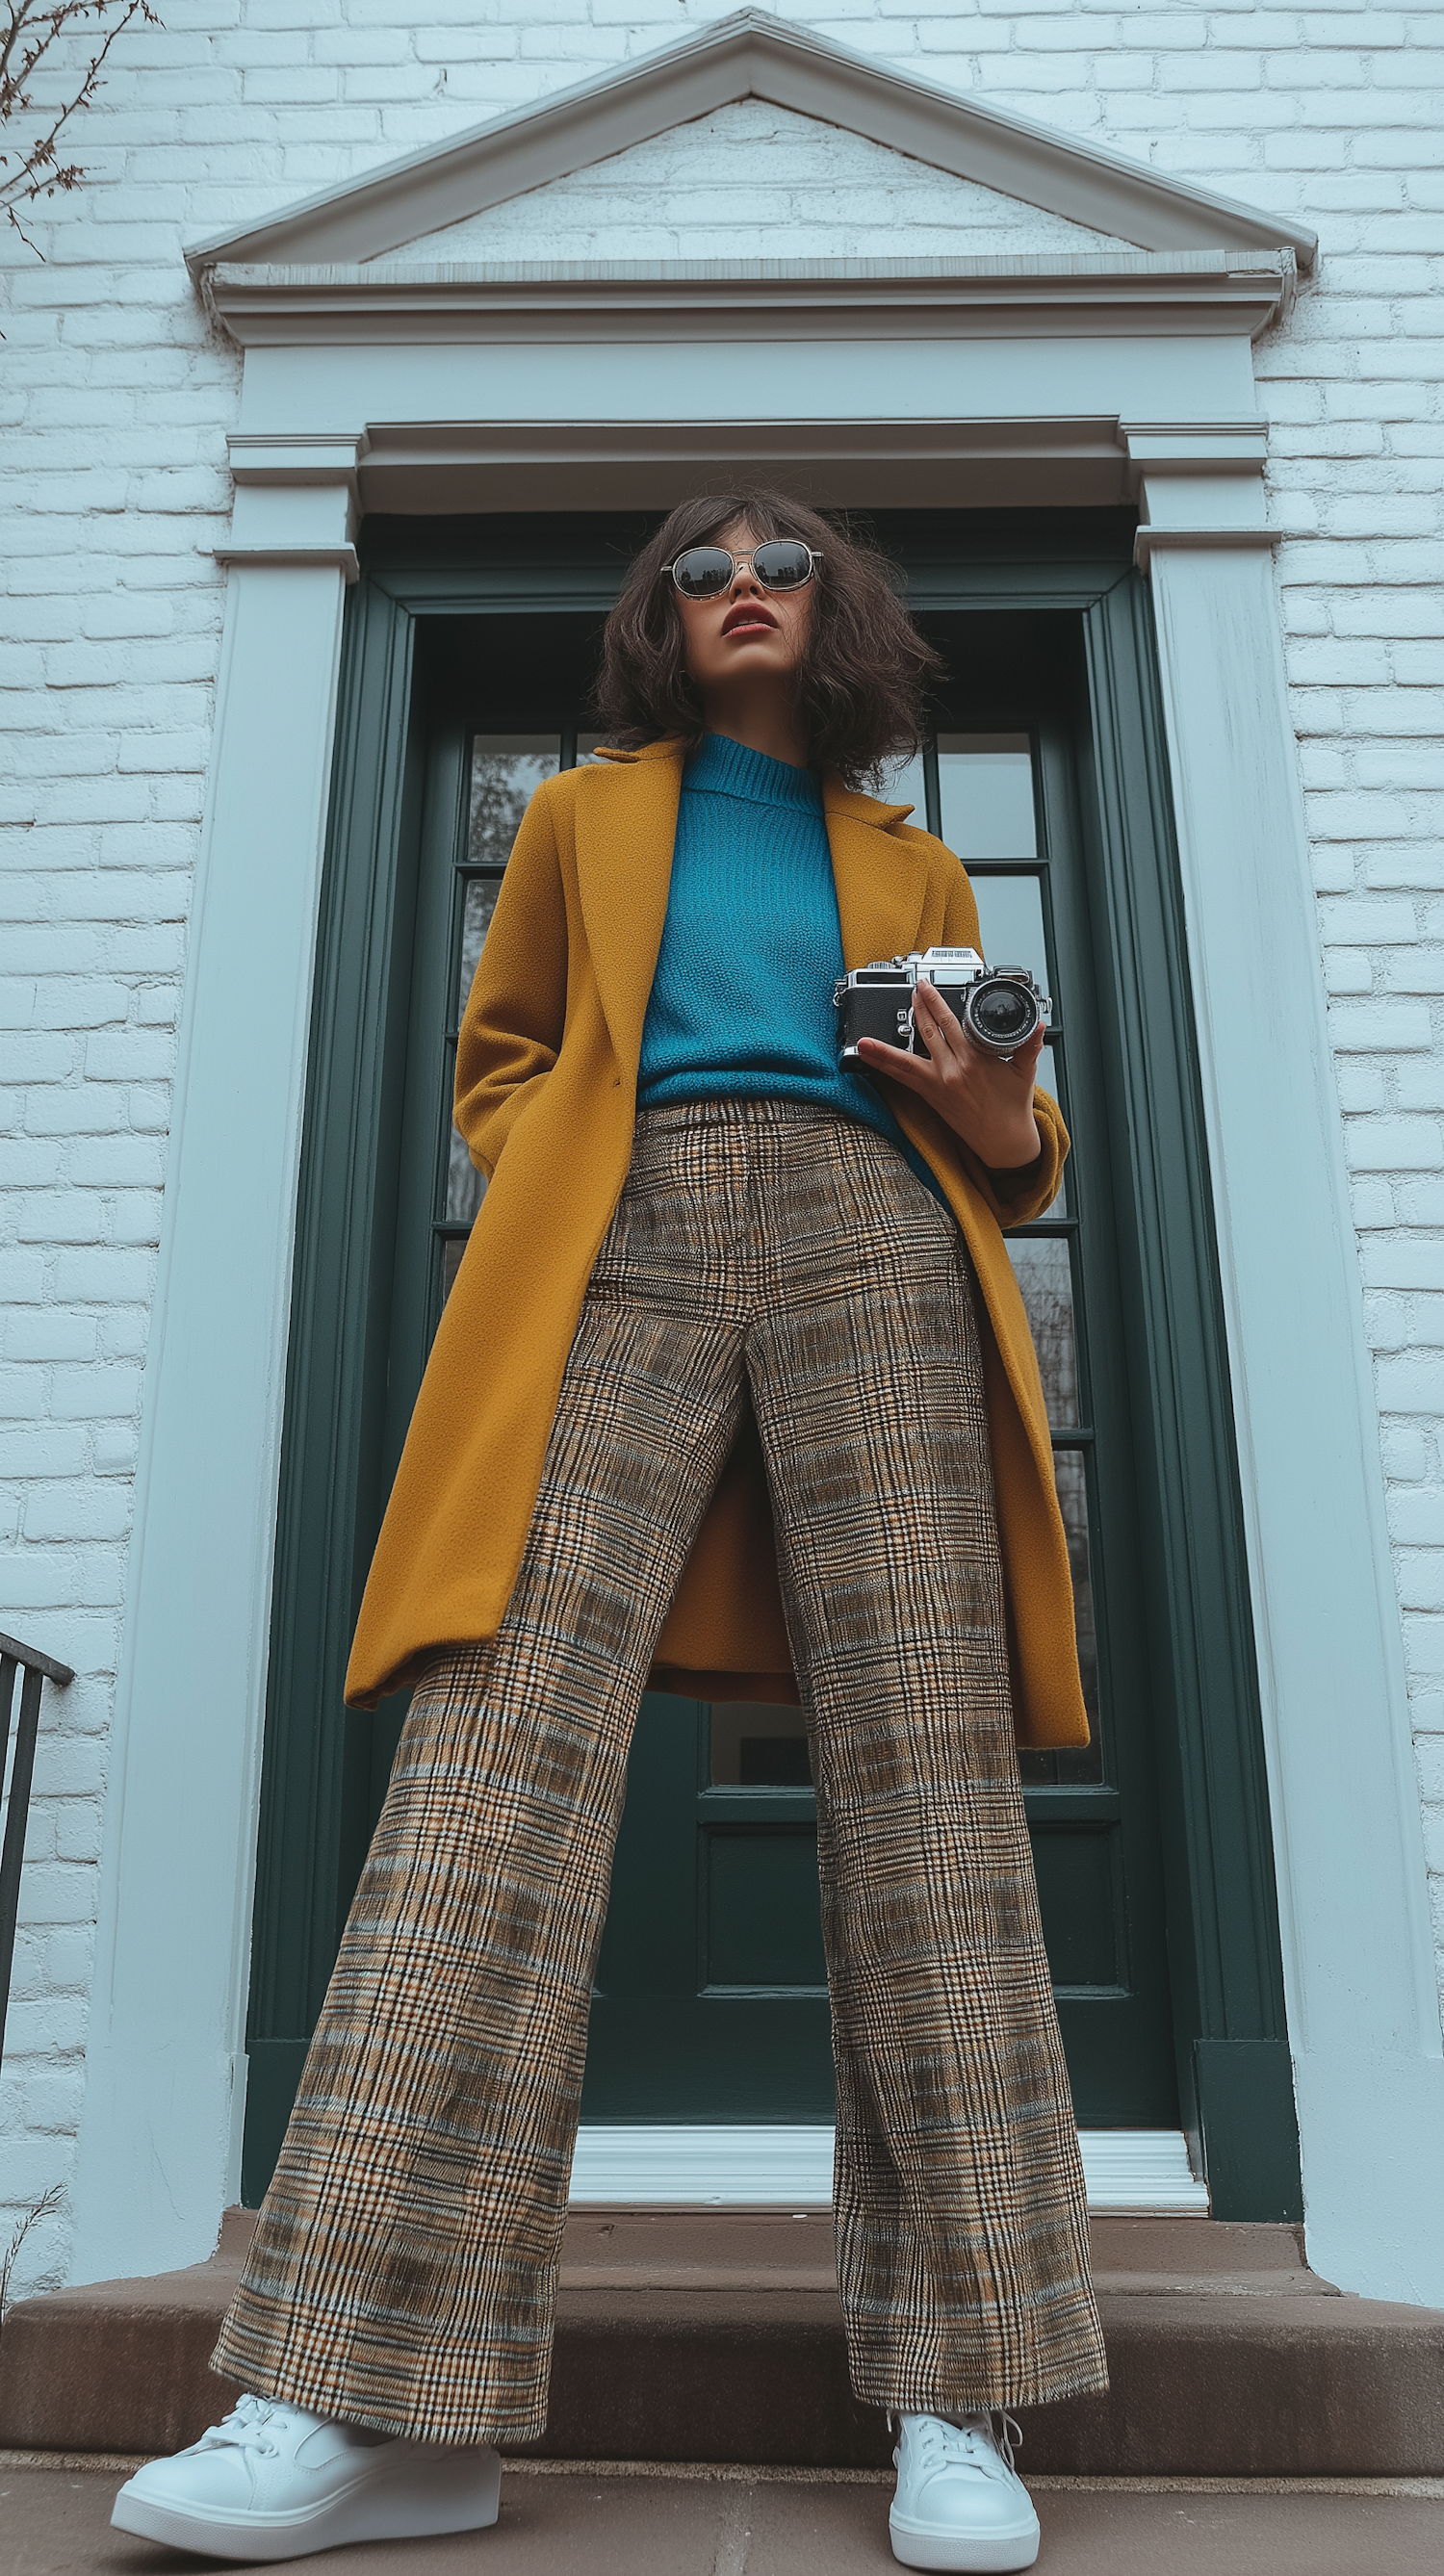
242 510 1298 2218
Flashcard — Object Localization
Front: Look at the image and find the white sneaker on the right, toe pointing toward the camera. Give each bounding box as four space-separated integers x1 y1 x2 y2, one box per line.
888 2409 1040 2576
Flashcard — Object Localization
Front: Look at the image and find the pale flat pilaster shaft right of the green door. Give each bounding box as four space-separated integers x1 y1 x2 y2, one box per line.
1153 548 1444 2306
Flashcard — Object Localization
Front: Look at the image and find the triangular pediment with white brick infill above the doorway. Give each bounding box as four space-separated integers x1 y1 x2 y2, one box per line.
186 11 1318 273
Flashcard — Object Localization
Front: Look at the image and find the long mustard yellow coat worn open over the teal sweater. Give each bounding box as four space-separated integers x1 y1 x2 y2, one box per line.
345 742 1089 1744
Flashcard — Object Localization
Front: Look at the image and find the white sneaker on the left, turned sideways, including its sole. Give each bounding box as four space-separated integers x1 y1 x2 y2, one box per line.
111 2396 502 2561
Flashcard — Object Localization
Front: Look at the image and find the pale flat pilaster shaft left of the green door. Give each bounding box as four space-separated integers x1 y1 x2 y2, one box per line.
69 558 343 2282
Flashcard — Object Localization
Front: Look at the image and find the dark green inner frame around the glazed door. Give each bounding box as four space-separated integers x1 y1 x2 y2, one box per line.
242 510 1302 2218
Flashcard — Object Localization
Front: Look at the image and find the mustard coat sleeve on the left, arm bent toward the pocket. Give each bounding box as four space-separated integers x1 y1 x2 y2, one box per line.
453 781 566 1177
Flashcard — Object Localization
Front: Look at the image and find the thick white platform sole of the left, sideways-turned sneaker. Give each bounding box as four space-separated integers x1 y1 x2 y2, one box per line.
111 2445 502 2565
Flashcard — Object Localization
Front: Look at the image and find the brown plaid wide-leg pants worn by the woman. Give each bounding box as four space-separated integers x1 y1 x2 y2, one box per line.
214 1100 1107 2442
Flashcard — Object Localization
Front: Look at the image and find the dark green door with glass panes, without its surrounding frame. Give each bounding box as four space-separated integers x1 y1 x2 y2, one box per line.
360 618 1176 2127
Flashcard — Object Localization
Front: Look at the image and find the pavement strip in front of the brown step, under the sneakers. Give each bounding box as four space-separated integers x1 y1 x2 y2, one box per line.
0 2453 1444 2576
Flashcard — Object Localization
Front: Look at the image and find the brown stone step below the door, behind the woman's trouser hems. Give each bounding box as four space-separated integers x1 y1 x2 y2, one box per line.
0 2207 1444 2478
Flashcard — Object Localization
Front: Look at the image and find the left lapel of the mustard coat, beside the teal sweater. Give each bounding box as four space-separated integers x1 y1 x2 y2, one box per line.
577 742 683 1074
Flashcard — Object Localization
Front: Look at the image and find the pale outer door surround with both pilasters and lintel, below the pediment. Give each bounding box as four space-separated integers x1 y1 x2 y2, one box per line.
72 287 1444 2303
